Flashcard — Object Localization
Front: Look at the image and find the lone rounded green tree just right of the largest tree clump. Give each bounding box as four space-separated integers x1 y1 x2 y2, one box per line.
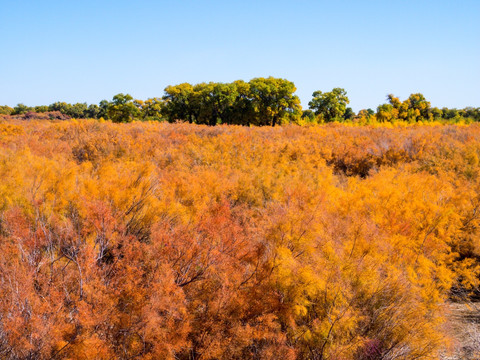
308 88 350 122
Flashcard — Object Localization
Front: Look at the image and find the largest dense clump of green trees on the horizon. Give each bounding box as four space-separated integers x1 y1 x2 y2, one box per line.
163 77 301 126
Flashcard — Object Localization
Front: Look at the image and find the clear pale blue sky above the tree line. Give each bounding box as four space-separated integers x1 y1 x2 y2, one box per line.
0 0 480 111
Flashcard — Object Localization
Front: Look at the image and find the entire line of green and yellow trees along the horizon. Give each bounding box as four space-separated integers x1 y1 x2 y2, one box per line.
0 77 480 126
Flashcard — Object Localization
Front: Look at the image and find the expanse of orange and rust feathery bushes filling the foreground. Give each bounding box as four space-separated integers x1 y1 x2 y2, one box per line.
0 121 480 360
